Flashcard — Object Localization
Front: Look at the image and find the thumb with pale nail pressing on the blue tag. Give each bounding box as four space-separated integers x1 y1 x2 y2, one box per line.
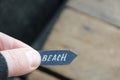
0 48 41 77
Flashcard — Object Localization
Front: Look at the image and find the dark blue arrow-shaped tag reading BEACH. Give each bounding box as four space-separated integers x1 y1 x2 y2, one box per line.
39 50 77 66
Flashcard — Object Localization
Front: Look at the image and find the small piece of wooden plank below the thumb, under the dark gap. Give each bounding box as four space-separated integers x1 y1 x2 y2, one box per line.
27 70 57 80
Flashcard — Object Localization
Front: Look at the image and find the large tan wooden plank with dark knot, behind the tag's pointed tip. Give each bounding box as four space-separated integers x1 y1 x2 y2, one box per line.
43 8 120 80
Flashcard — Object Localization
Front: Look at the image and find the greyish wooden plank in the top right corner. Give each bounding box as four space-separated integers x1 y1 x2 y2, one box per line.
68 0 120 27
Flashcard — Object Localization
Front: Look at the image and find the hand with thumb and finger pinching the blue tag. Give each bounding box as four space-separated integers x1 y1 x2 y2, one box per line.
0 32 41 77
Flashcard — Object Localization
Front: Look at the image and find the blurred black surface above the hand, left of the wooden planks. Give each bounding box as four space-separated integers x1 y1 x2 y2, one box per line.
0 0 61 45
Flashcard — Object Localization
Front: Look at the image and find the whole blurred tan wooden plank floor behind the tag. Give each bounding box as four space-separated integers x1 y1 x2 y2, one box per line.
28 0 120 80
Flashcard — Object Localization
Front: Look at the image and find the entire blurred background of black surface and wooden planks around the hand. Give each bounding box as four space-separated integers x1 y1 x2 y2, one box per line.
0 0 120 80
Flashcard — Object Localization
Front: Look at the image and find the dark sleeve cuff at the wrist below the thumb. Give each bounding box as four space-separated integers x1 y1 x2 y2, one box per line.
0 53 8 80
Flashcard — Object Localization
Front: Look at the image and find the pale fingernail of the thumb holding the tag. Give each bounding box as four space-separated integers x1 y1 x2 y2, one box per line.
26 50 40 68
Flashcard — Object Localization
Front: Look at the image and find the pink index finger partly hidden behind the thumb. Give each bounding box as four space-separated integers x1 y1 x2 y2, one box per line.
0 32 30 50
